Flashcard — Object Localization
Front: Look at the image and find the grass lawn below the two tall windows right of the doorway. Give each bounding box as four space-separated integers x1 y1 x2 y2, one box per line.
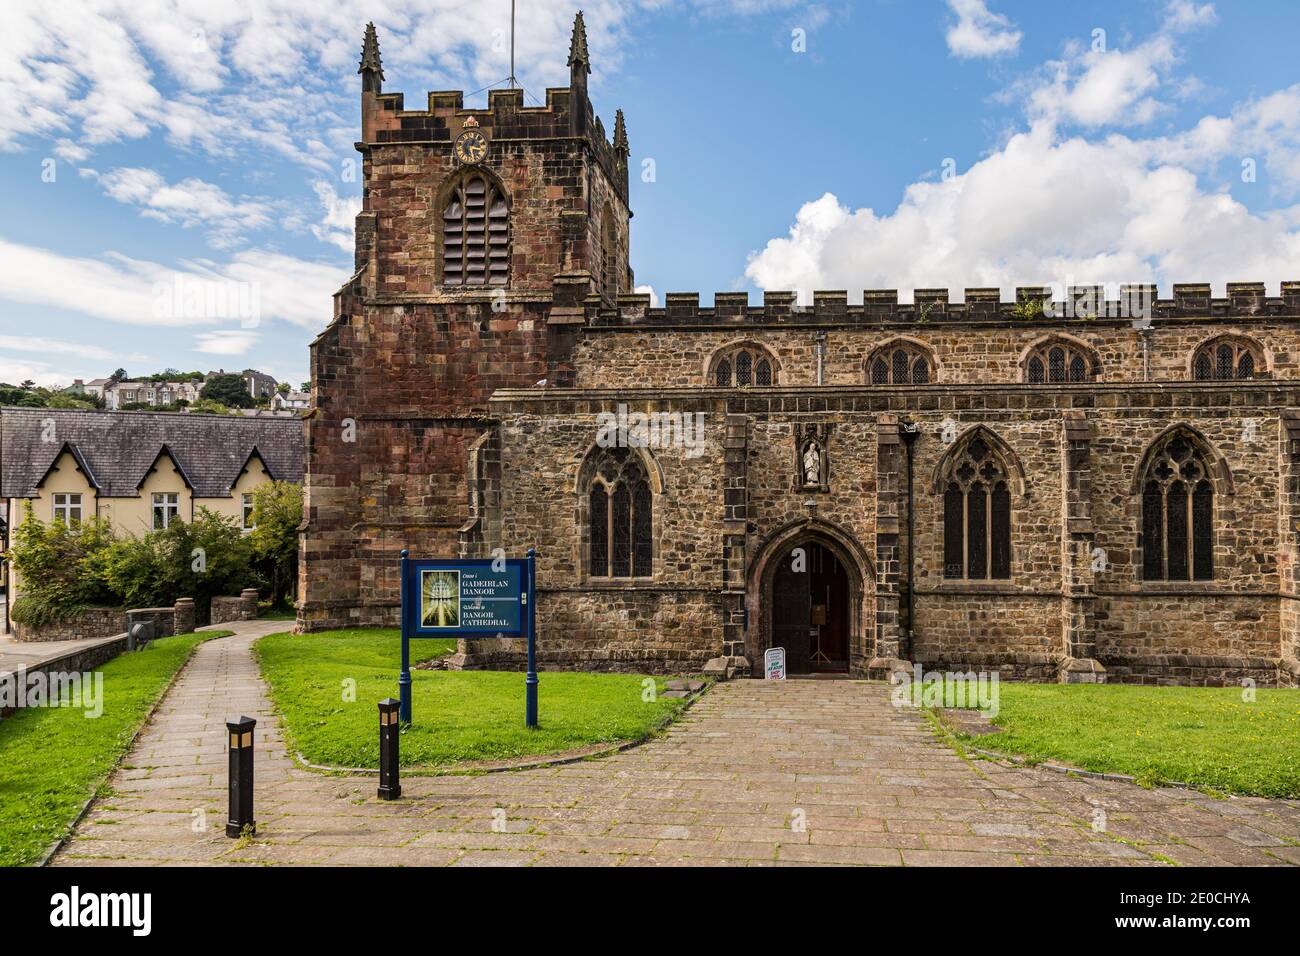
941 683 1300 797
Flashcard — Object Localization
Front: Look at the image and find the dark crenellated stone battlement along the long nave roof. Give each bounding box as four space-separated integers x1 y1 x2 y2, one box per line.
585 281 1300 328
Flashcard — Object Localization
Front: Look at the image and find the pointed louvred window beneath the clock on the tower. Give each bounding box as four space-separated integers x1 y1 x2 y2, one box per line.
442 173 510 286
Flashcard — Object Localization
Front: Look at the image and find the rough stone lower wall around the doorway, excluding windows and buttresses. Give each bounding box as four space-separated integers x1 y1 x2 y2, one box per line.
493 382 1300 683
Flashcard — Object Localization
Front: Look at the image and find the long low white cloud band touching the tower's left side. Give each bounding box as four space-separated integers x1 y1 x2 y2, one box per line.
0 238 348 329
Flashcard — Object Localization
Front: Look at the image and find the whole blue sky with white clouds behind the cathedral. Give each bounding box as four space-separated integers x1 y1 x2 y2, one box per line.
0 0 1300 384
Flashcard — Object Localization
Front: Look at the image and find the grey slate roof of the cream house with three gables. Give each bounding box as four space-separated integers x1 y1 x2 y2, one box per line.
0 407 303 498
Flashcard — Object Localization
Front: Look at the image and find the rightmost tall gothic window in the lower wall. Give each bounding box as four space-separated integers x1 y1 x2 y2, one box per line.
1141 429 1214 581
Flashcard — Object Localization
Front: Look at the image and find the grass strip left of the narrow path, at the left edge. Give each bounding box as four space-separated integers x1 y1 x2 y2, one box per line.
0 631 230 866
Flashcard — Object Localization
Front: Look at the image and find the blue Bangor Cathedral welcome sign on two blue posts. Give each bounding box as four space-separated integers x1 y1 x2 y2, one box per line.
398 548 537 727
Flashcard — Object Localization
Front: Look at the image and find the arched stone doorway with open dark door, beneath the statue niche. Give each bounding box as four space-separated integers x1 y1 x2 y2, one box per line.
745 522 875 675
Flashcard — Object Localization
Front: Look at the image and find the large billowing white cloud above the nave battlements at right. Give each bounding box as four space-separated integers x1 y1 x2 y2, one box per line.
746 124 1300 295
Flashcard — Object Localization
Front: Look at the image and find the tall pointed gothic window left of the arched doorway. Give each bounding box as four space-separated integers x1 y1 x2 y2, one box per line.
586 447 654 578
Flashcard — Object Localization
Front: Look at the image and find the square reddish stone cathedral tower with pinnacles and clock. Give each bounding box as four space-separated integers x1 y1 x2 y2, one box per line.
298 13 632 631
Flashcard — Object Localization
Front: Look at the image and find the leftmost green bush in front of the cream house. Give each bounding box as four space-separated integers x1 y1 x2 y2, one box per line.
9 502 117 627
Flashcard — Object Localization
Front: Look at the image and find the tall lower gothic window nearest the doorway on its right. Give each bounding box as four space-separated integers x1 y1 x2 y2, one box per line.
941 432 1011 580
